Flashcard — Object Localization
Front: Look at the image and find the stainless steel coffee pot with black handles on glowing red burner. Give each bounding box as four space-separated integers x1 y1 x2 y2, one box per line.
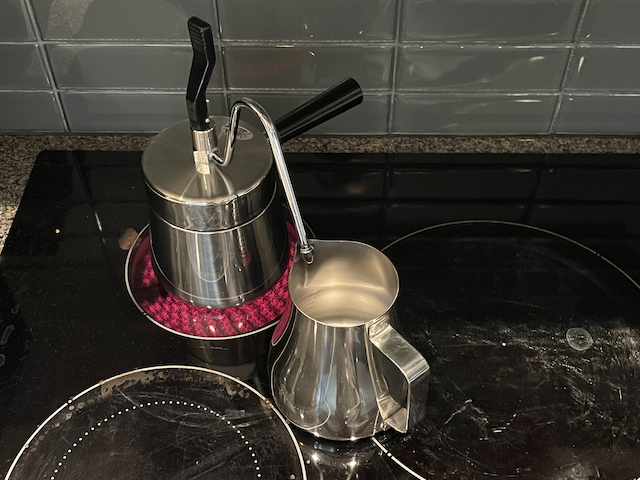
142 17 362 308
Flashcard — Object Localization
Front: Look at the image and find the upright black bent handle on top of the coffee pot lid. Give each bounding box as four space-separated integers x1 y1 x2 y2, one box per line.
187 17 216 131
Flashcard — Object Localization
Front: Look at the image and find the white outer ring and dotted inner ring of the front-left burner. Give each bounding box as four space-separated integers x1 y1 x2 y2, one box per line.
5 365 307 480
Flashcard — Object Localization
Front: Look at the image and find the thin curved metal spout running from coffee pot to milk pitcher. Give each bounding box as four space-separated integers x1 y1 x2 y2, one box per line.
212 98 313 263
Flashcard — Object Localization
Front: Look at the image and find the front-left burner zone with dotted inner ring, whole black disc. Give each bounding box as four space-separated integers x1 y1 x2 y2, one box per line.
7 366 306 480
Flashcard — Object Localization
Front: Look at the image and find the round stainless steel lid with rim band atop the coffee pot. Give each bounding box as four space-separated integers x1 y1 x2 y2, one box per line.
142 116 276 231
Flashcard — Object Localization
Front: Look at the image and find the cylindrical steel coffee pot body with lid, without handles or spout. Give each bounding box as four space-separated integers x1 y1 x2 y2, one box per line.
142 117 288 308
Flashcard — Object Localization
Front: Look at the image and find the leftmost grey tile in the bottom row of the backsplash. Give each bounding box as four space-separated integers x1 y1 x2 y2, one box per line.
0 92 64 132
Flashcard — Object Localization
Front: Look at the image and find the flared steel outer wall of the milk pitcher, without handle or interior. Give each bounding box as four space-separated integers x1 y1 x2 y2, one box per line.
270 308 389 440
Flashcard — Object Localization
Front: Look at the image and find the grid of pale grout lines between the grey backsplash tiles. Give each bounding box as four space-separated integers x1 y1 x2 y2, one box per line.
0 0 640 135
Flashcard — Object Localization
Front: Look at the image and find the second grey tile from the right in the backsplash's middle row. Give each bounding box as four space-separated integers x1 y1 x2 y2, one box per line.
396 45 569 92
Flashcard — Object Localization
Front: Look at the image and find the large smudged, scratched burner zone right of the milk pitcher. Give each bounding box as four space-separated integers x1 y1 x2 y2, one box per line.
377 222 640 480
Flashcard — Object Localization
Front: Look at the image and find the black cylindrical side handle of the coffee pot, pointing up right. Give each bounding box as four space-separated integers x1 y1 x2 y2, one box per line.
274 78 363 143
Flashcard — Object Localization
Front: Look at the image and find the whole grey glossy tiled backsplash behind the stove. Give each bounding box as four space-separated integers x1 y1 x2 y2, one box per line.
0 0 640 135
